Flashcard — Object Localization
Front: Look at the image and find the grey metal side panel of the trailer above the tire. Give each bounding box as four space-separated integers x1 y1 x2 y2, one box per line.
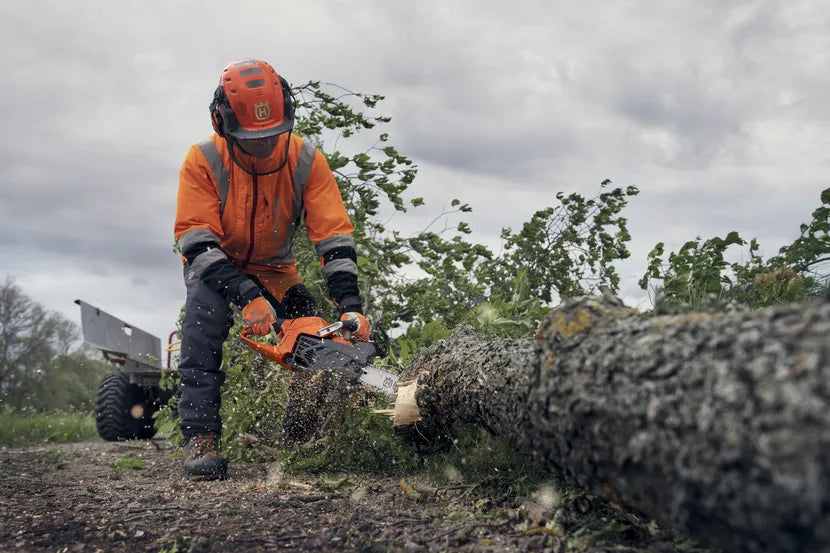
75 300 162 372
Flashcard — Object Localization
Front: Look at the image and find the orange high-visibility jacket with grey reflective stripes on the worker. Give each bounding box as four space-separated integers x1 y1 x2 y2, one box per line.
174 134 357 280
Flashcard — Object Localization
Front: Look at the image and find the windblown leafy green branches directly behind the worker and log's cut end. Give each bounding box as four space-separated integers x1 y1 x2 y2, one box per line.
284 81 637 340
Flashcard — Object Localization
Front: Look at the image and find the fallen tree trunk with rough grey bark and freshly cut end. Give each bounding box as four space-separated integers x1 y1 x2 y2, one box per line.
396 297 830 551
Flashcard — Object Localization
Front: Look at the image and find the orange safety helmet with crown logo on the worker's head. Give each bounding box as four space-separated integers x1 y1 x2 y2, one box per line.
210 58 294 140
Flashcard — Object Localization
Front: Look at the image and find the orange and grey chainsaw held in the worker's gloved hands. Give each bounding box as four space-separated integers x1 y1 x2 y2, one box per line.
239 317 400 398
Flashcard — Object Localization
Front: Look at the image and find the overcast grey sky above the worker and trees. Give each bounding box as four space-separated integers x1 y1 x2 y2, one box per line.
0 0 830 354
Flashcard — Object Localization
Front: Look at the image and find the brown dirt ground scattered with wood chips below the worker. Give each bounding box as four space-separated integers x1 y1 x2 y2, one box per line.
0 440 708 553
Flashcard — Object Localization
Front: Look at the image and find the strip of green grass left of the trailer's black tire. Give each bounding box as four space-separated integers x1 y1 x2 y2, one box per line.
0 411 98 447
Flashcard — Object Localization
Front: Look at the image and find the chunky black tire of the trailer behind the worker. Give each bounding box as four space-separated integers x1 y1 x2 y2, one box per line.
95 372 156 442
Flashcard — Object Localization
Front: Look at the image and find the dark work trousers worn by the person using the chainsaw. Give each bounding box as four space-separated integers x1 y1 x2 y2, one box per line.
179 265 317 436
